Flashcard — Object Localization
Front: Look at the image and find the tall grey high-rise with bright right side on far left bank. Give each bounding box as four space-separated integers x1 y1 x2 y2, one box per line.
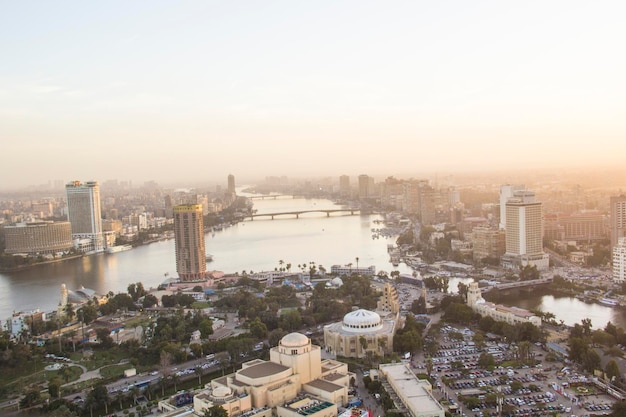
65 181 104 252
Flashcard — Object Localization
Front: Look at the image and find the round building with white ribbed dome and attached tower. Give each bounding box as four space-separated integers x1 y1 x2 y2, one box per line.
324 284 399 358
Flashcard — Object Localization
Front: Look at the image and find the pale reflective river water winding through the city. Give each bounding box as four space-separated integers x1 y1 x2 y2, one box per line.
0 193 626 328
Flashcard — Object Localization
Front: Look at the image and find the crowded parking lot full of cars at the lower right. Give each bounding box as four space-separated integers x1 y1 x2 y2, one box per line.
413 326 615 417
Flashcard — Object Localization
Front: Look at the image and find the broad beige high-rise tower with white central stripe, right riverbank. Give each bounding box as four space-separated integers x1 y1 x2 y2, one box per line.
504 191 549 270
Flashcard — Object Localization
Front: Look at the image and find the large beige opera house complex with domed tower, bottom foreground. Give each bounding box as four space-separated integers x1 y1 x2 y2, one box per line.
194 333 355 417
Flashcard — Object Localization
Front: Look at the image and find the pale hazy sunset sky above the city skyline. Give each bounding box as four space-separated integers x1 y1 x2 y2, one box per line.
0 0 626 188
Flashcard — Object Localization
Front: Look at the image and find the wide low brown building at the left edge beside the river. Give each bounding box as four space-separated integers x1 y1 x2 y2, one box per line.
4 221 73 255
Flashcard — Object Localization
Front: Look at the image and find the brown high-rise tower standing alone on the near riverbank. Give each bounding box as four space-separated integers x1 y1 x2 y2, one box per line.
174 204 206 281
